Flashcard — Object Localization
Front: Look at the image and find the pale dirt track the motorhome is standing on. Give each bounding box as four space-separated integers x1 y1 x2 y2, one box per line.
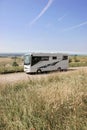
0 67 87 84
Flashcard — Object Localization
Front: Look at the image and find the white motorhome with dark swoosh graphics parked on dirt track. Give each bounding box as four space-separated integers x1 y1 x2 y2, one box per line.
24 53 68 73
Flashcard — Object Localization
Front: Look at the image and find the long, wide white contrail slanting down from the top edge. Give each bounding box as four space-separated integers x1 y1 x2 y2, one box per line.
30 0 54 25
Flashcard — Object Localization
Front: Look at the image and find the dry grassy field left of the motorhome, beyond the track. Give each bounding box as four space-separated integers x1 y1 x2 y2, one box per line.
0 57 23 74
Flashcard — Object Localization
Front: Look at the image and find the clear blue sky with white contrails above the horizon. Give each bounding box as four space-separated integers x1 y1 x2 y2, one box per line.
0 0 87 54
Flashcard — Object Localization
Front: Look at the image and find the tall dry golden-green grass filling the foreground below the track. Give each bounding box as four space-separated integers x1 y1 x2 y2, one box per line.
0 71 87 130
